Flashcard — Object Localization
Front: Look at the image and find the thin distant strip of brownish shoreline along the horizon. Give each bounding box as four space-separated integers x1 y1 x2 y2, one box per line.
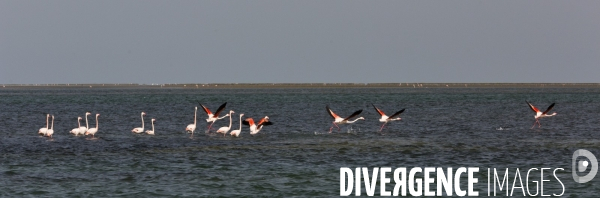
0 83 600 90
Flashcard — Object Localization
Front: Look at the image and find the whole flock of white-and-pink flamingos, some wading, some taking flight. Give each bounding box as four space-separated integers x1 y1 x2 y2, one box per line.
38 101 556 138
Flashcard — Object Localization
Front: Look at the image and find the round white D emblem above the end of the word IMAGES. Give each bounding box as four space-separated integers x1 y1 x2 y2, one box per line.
572 149 598 183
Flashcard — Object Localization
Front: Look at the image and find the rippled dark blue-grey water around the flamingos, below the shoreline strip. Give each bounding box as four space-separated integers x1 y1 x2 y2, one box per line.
0 88 600 197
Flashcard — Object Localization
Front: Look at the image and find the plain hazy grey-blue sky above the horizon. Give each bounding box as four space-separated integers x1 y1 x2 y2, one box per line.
0 0 600 84
